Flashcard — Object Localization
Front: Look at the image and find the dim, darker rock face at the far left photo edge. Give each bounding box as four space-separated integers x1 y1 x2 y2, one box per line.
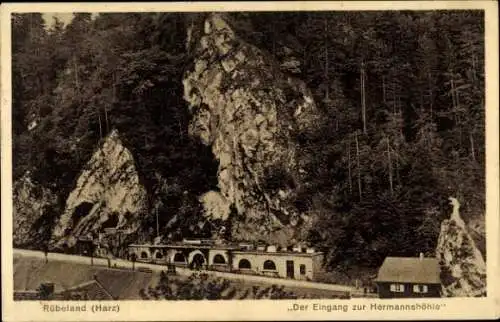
12 172 56 247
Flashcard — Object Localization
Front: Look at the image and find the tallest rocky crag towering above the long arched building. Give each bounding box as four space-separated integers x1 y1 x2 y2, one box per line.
183 14 318 243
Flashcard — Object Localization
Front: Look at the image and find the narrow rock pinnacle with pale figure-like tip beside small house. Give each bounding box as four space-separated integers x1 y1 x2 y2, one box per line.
436 198 486 297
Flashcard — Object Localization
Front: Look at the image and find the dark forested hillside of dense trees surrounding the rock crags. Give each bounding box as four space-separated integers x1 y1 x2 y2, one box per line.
12 11 485 268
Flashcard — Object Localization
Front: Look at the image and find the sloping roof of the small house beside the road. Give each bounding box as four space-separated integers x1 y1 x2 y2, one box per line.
375 257 441 284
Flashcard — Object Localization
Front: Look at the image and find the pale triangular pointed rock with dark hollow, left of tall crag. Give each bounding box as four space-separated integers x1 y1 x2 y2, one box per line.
52 131 146 246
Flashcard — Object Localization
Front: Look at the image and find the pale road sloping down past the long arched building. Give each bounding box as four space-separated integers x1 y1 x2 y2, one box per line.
13 249 359 294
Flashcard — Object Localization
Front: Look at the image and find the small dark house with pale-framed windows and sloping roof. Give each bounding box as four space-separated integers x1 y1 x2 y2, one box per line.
374 254 441 298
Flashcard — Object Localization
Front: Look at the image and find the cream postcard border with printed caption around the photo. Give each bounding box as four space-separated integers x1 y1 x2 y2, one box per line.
0 1 500 321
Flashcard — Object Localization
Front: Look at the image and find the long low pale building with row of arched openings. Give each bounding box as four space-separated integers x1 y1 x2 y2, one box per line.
129 240 323 280
